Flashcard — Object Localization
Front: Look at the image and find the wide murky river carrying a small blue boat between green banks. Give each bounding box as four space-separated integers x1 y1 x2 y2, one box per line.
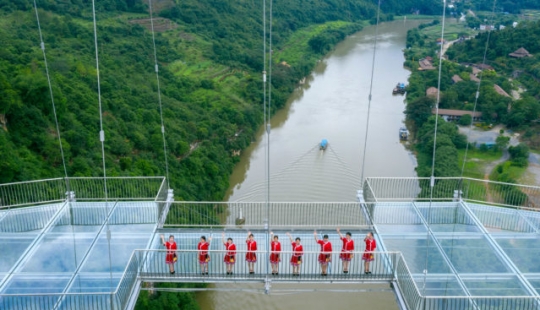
197 21 420 310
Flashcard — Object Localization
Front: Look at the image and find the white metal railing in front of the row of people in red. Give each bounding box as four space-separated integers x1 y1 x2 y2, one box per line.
132 249 401 282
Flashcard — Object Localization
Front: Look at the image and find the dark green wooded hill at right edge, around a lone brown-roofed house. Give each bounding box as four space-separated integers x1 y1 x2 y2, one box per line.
448 22 540 135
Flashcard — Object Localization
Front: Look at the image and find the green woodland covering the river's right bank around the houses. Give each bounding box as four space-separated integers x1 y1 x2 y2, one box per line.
405 17 540 193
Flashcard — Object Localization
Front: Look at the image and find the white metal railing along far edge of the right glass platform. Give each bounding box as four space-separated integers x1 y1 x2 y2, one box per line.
364 177 540 208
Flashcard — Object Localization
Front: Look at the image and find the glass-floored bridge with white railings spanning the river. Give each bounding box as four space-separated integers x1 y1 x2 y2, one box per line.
0 177 540 309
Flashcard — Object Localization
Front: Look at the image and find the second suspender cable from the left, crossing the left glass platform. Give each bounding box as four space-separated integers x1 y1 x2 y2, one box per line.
92 0 114 296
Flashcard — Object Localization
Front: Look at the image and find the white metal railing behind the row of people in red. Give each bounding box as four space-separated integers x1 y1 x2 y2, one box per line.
163 201 370 228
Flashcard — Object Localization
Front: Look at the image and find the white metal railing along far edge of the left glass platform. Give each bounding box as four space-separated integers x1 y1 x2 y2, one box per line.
0 177 165 208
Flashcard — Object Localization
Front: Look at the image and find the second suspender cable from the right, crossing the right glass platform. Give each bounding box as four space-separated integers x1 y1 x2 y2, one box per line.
422 0 446 293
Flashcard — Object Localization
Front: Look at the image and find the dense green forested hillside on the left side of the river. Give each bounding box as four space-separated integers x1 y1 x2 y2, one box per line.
0 0 376 200
